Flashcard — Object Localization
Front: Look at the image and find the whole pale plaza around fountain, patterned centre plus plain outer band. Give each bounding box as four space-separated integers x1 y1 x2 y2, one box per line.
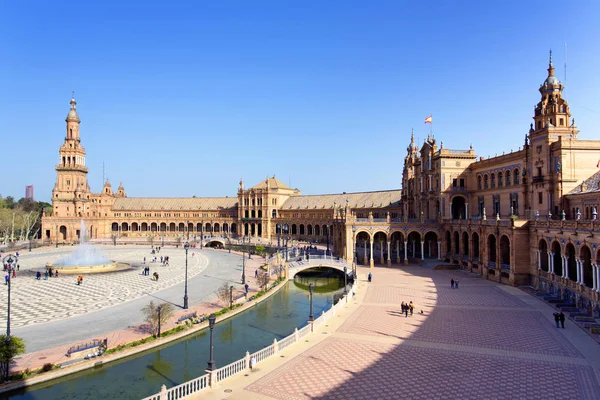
0 245 254 356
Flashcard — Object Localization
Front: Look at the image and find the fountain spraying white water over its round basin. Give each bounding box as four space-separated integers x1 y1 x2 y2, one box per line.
46 220 131 274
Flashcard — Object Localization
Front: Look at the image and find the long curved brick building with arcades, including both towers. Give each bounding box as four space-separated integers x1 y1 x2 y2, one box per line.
42 55 600 306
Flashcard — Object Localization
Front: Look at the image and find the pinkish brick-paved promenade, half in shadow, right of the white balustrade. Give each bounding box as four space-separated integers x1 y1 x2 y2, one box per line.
196 266 600 400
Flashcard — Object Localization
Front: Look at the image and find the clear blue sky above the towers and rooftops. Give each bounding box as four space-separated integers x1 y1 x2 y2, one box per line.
0 1 600 200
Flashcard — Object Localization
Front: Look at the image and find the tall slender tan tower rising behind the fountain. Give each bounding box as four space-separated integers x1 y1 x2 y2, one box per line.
52 94 89 216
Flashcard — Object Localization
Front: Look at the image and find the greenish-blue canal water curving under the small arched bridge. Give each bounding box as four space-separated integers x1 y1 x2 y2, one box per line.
0 277 344 400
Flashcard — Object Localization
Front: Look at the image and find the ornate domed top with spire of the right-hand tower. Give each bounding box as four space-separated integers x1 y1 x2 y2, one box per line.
529 50 579 142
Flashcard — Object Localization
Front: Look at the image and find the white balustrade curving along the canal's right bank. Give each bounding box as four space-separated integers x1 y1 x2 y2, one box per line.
142 283 355 400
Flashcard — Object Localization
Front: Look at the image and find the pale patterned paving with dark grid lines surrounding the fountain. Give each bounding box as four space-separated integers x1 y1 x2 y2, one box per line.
0 247 207 328
